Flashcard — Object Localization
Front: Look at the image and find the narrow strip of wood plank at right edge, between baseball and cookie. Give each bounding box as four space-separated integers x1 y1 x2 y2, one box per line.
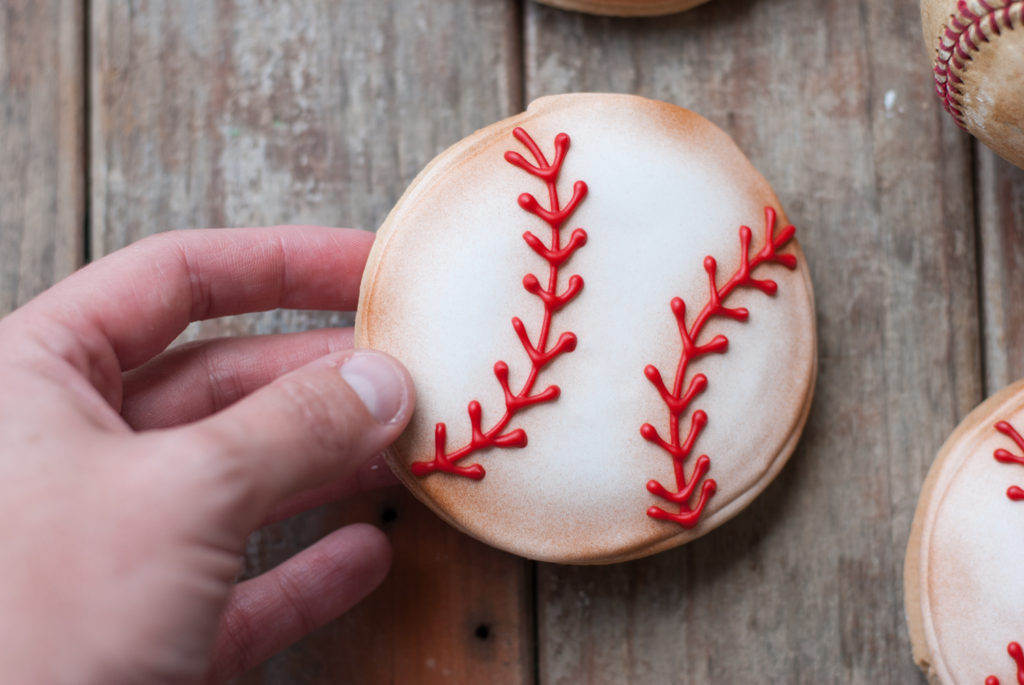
977 148 1024 394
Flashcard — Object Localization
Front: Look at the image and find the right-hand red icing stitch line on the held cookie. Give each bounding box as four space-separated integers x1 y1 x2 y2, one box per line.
640 207 797 528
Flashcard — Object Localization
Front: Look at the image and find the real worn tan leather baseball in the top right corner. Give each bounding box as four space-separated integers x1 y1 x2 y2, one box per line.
921 0 1024 167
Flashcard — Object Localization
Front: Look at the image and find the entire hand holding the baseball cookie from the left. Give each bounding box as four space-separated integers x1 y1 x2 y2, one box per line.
0 227 413 683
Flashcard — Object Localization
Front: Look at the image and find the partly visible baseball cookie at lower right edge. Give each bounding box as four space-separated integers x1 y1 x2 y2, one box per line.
904 381 1024 685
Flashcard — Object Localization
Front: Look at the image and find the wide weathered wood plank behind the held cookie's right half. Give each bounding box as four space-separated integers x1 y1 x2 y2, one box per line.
524 0 982 683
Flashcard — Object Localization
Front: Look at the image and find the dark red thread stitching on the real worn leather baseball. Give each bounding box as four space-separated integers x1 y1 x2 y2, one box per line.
934 0 1024 129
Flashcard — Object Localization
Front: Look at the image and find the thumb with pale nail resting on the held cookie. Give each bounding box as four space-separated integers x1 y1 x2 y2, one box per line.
182 349 414 518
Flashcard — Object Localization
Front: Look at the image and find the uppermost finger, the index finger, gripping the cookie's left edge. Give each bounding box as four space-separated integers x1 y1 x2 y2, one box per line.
14 226 374 371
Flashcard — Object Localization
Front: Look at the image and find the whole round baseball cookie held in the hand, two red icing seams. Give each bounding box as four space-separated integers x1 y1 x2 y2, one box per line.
356 94 816 563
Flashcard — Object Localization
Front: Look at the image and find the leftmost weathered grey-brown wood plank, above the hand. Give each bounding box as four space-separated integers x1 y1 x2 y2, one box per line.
0 0 85 314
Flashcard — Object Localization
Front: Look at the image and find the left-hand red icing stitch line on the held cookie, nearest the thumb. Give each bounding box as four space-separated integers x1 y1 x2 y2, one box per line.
411 127 587 480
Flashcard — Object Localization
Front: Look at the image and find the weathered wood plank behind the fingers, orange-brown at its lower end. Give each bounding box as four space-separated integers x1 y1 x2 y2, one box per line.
90 0 532 683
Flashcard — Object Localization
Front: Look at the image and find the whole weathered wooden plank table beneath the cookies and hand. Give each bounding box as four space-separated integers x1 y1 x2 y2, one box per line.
0 0 1024 684
